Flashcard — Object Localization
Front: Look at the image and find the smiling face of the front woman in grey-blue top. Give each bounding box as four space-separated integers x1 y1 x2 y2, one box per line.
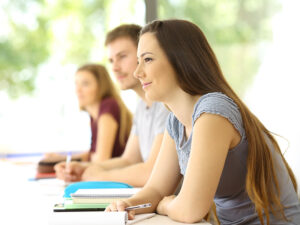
134 32 179 103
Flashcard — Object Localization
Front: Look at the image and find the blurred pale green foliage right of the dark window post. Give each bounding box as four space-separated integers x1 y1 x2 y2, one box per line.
159 0 278 94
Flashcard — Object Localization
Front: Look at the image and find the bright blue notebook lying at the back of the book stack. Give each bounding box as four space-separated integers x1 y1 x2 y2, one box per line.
63 181 132 198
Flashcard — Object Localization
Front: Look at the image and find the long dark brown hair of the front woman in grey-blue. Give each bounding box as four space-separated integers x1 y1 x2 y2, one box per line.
141 20 297 225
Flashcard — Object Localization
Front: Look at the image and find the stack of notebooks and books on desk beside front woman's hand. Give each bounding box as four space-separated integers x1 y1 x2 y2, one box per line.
48 185 155 225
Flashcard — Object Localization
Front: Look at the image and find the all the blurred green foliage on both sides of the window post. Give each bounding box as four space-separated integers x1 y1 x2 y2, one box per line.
0 0 280 99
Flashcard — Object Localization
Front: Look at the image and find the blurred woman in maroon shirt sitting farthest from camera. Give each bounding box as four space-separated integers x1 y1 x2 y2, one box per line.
40 64 132 169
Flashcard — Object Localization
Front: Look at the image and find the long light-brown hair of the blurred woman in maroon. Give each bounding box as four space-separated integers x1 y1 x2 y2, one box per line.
77 64 132 147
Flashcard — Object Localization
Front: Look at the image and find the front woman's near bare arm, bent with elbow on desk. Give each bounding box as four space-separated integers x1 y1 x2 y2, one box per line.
161 113 240 223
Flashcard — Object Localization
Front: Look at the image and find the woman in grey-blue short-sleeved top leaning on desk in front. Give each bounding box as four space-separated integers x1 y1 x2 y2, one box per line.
106 20 300 225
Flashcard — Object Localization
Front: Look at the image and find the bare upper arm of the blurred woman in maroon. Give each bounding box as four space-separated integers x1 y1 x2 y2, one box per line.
92 113 119 163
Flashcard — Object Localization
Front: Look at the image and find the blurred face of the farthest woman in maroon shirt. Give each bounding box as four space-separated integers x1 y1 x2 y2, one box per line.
75 70 98 107
